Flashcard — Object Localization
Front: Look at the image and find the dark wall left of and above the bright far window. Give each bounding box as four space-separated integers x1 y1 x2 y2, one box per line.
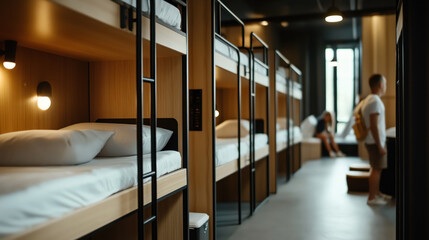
274 19 361 118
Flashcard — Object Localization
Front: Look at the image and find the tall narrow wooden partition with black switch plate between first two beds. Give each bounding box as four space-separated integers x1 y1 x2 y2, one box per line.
188 0 215 239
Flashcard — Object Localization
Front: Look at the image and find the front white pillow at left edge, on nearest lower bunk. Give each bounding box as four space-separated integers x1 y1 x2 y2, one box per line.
0 130 113 166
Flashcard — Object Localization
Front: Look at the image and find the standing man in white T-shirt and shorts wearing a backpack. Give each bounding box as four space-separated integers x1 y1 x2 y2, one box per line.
361 74 391 205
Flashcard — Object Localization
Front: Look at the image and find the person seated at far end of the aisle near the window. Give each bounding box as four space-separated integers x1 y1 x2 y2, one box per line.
315 111 346 158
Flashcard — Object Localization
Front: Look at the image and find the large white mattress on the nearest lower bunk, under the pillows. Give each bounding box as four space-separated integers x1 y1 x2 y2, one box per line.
0 151 182 238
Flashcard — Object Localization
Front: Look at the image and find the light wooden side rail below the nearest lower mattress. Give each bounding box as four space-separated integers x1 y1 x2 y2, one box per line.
3 169 187 240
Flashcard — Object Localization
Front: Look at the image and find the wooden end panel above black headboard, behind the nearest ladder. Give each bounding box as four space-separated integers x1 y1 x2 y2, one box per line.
90 57 182 154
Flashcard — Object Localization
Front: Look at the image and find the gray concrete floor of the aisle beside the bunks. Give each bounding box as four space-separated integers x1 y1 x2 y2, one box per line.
221 157 395 240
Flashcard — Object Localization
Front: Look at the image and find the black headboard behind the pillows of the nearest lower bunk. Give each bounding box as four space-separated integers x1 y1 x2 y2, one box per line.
96 118 179 151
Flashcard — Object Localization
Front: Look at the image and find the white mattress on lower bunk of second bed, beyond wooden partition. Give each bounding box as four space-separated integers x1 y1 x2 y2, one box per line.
216 133 268 166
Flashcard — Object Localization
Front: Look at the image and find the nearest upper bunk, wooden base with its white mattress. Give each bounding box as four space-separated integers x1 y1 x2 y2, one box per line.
0 0 187 61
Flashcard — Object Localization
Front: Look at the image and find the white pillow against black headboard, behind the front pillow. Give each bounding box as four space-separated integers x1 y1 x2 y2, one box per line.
63 122 173 157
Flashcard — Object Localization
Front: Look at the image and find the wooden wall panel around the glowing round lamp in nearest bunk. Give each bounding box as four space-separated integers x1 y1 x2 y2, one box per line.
0 46 89 133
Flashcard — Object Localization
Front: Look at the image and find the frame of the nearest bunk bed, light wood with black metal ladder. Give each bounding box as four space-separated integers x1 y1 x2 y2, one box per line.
0 0 189 240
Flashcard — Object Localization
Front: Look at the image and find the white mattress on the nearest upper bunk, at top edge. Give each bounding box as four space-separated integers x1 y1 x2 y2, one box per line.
121 0 182 29
